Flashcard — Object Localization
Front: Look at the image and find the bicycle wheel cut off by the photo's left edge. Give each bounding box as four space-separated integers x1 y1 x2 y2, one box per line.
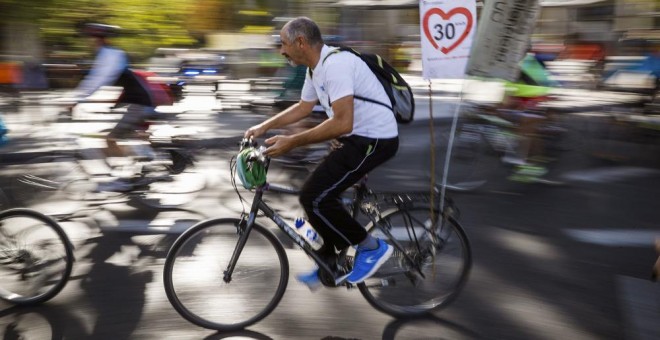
0 208 74 305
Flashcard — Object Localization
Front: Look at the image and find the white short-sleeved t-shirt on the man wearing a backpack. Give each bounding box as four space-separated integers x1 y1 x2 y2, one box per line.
301 45 398 138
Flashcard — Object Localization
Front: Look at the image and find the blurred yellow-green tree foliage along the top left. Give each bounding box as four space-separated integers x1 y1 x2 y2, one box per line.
0 0 286 62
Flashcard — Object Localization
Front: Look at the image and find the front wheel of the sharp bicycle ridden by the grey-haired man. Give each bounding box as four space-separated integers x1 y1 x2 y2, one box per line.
163 218 289 331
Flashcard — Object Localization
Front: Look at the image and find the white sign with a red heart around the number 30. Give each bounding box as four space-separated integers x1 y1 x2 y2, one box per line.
419 0 476 78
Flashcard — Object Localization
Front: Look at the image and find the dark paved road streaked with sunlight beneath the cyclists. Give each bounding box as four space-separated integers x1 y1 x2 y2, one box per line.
0 88 660 340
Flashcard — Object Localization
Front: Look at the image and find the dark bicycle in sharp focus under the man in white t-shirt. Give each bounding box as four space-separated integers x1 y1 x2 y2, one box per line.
163 140 472 331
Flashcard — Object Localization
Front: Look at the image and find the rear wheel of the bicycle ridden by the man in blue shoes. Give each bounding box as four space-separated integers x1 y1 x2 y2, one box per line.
358 207 472 317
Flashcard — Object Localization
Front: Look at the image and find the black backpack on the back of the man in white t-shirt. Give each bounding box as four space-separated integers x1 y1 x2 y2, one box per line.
309 47 415 124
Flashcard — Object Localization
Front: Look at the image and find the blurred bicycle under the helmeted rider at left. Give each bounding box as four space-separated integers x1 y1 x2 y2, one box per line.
10 125 201 209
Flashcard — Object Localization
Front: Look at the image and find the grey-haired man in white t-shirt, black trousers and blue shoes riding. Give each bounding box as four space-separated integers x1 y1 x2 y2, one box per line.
245 17 399 288
